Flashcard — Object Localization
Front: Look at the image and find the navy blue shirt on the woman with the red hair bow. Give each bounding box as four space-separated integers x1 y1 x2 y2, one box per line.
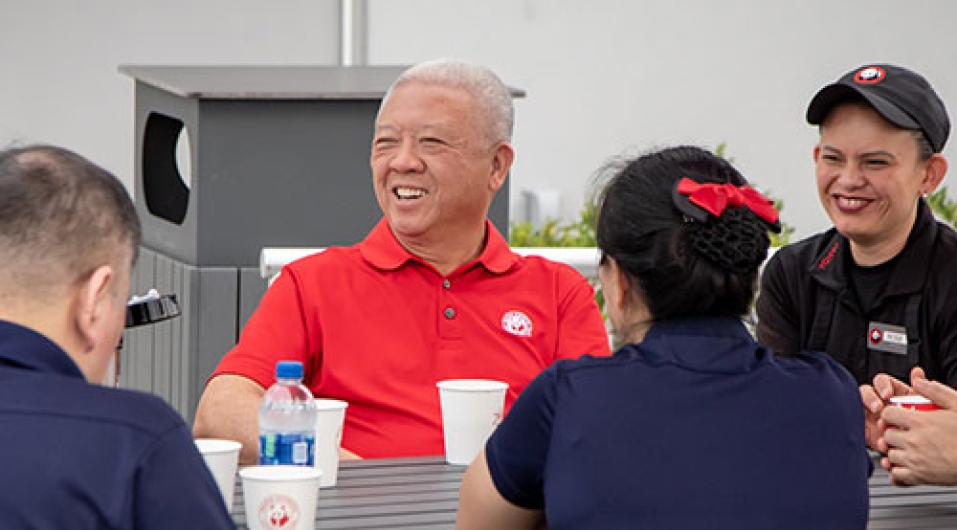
486 319 871 530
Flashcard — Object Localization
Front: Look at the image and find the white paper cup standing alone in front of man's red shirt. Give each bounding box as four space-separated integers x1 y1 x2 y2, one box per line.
436 379 508 464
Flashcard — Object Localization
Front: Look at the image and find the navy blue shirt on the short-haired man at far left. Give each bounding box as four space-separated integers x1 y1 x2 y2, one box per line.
0 321 233 530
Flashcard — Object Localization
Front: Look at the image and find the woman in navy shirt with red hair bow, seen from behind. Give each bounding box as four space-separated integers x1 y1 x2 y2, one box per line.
458 147 870 530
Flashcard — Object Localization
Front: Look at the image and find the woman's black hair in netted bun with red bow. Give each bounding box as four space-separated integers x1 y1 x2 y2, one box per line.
597 142 777 321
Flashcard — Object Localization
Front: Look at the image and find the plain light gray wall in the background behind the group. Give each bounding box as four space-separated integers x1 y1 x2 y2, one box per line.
0 0 957 236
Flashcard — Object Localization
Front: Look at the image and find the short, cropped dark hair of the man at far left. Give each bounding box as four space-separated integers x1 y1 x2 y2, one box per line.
0 145 141 289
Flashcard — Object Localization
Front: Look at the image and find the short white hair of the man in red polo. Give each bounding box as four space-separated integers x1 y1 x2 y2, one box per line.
382 59 515 144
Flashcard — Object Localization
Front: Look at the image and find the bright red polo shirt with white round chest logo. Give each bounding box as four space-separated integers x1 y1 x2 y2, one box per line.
213 220 610 457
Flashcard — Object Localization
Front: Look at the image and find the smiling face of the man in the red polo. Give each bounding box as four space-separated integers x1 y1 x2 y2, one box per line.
371 83 502 248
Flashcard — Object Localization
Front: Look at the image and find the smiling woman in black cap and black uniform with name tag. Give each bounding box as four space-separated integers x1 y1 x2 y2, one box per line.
757 64 957 462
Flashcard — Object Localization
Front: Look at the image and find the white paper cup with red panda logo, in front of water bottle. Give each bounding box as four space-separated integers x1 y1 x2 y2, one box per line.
239 466 322 530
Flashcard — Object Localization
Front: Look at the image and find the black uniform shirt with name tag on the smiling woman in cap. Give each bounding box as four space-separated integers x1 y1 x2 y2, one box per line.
757 200 957 387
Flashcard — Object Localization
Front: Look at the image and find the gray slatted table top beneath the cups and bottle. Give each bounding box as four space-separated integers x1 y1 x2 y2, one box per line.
233 457 957 530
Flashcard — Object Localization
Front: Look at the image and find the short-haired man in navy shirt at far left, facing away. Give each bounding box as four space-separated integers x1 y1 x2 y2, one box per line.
0 146 233 530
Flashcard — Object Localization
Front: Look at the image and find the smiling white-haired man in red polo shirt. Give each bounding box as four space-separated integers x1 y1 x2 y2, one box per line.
194 61 610 463
